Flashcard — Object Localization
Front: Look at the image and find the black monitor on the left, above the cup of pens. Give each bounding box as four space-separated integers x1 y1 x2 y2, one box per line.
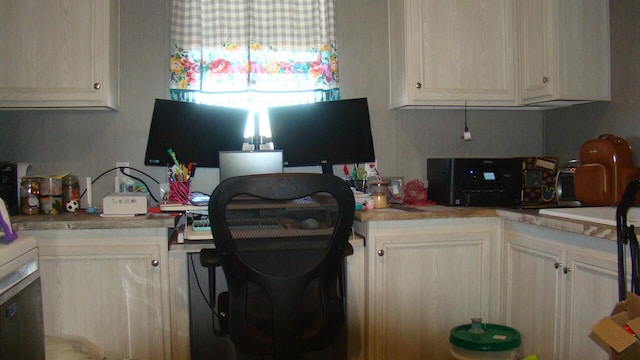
144 99 249 167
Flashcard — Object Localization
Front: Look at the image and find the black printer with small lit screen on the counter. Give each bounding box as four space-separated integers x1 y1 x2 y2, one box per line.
427 158 522 207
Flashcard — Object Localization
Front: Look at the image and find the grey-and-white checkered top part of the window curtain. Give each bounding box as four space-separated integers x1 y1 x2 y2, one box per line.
172 0 336 50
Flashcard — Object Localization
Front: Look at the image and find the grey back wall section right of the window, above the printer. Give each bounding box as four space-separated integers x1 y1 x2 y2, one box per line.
338 0 543 186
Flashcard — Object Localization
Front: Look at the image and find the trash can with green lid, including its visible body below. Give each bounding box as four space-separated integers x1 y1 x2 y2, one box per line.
449 318 521 360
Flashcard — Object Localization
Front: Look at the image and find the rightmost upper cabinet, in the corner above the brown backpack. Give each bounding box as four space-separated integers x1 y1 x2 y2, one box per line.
516 0 611 104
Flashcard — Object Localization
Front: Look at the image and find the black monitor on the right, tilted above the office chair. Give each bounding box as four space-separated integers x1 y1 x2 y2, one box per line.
268 98 376 173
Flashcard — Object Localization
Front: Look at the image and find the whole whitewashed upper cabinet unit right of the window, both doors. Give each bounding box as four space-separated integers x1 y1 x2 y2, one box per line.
388 0 611 108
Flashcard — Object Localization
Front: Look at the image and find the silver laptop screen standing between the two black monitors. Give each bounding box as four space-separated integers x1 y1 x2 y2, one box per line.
219 150 283 182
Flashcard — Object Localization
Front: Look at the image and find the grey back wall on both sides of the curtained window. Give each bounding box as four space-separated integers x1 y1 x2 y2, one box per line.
0 0 548 207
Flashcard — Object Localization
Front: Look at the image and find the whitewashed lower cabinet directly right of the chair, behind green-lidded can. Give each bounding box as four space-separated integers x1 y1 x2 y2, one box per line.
354 218 499 359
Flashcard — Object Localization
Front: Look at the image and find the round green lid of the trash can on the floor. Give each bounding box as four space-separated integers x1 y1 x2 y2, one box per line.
449 324 520 351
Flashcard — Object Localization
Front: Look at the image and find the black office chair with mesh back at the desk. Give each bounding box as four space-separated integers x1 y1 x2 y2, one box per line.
200 174 354 359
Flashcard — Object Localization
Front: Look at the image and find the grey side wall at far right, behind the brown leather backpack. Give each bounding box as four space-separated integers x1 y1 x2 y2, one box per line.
544 0 640 165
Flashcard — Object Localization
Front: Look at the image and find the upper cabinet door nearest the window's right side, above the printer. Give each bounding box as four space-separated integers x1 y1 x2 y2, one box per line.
405 0 516 105
